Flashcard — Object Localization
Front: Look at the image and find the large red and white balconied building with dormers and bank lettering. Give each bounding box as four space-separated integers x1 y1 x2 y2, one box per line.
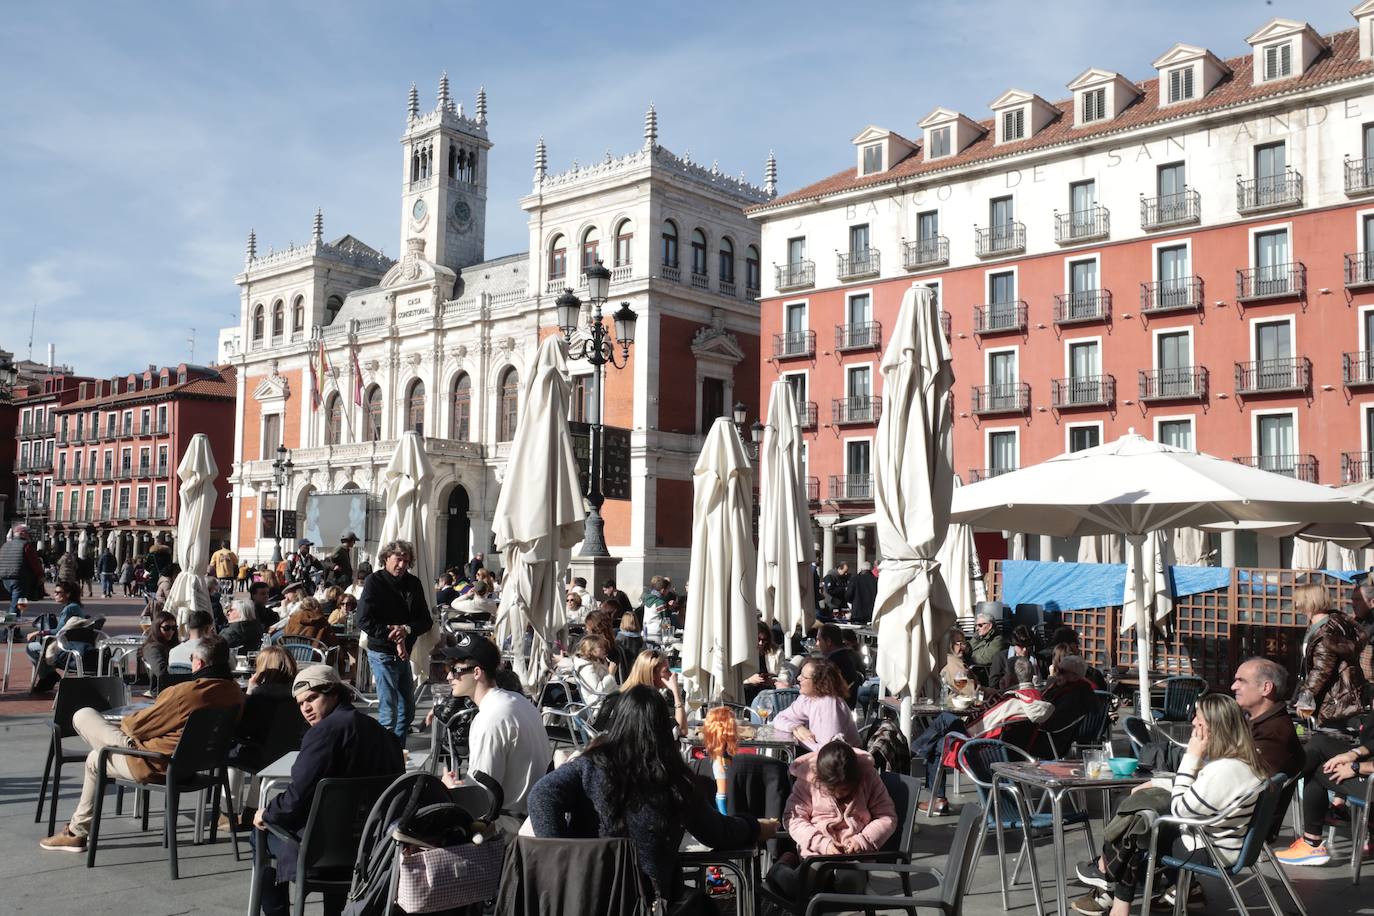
750 10 1374 566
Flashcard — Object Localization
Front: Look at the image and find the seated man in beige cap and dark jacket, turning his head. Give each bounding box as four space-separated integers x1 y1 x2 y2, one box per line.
251 665 405 916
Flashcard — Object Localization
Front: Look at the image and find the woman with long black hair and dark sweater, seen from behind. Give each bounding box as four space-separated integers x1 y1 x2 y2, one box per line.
529 687 778 904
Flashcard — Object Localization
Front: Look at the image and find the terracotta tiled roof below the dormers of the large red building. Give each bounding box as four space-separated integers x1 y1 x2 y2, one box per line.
745 29 1374 216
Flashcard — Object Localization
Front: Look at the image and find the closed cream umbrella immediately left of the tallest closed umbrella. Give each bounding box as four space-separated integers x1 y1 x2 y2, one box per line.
756 379 816 656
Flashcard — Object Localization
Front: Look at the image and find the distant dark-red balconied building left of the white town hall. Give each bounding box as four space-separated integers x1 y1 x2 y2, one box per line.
45 363 235 560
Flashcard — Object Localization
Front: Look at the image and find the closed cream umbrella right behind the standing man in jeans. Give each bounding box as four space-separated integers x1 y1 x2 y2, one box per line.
374 430 438 684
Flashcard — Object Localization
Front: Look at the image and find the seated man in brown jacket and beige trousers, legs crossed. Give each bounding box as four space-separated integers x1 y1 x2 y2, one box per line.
38 636 243 853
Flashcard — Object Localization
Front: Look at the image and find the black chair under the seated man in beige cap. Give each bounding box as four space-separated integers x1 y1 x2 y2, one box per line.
249 776 396 916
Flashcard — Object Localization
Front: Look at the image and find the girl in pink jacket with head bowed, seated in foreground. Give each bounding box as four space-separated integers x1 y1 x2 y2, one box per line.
768 742 897 900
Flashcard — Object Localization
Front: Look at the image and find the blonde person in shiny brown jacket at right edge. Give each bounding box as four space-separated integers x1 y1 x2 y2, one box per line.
1293 585 1369 728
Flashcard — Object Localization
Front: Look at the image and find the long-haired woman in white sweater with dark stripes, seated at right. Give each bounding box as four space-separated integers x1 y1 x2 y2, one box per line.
1073 694 1268 916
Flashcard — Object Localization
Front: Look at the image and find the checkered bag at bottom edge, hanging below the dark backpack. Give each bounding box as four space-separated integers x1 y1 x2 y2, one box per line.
396 836 506 913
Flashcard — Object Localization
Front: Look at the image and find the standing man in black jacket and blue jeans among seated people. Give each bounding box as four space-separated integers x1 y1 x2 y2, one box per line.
357 541 434 743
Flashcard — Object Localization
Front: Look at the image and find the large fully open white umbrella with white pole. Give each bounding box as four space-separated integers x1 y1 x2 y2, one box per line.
952 431 1370 717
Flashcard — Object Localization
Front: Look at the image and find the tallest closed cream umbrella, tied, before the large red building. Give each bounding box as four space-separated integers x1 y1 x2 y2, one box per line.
872 286 966 736
